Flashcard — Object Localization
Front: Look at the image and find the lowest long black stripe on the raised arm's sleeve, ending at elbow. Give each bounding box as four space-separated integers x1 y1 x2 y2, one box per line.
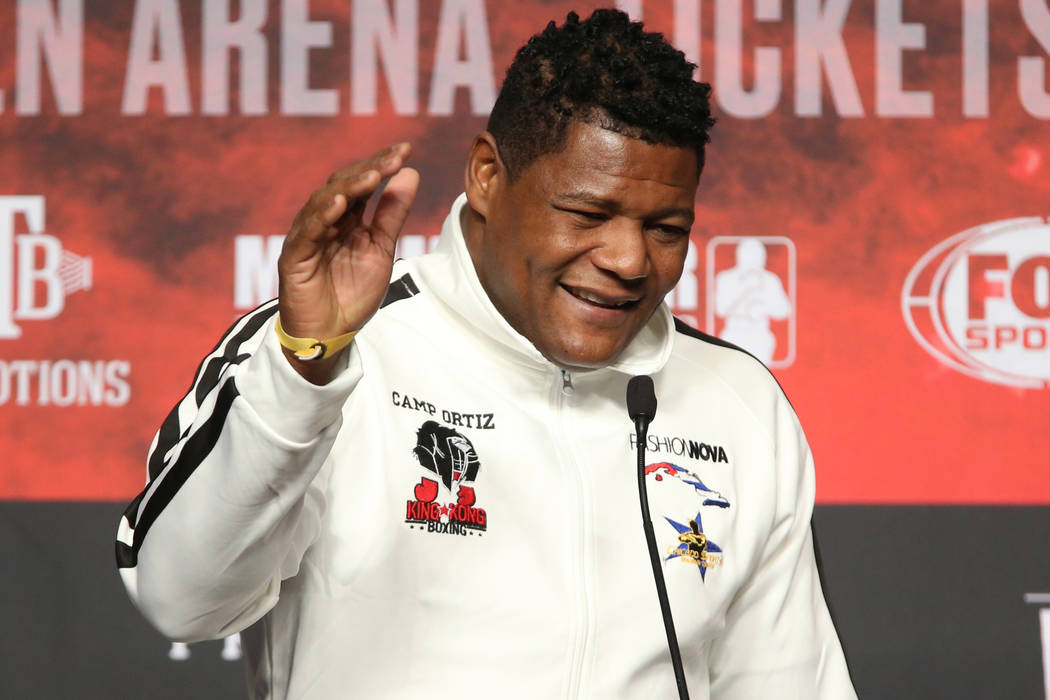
117 377 240 568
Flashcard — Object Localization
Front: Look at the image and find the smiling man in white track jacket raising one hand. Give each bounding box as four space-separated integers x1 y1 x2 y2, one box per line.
118 10 855 700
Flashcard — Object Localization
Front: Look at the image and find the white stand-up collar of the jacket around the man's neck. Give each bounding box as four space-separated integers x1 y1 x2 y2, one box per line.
415 194 674 375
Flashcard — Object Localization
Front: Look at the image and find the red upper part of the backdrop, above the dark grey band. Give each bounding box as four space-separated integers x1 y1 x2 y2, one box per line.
0 0 1050 504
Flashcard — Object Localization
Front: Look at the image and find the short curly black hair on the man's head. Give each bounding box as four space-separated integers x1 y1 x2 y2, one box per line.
488 9 714 181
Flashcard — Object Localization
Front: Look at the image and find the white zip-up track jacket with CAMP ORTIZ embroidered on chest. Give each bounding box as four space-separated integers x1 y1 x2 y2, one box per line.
117 195 856 700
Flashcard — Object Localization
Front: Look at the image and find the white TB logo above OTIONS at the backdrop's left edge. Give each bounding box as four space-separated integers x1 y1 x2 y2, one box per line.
0 195 91 339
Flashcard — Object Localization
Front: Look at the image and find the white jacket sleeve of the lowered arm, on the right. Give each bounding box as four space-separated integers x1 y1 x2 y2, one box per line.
710 391 857 700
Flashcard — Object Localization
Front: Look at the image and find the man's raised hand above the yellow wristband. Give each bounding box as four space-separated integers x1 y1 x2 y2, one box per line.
277 144 419 384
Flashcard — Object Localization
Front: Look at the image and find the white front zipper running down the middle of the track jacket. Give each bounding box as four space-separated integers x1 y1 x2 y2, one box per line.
553 369 592 700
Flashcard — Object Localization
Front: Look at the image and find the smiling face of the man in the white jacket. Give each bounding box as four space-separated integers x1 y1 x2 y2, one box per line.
468 122 697 367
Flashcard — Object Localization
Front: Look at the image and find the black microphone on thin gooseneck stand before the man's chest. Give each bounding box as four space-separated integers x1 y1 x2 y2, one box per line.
627 375 689 700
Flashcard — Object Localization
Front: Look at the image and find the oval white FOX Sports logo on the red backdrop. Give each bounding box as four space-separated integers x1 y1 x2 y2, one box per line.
901 217 1050 389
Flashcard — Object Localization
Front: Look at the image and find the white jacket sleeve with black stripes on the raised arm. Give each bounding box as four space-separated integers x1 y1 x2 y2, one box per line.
117 301 361 641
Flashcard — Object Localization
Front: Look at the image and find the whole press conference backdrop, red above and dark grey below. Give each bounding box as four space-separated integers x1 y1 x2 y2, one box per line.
0 0 1050 700
